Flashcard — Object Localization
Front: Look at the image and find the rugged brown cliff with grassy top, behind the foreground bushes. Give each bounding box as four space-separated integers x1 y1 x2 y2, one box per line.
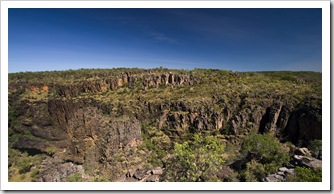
9 69 322 180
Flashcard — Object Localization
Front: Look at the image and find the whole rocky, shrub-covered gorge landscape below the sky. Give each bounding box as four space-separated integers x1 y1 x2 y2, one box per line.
8 68 322 181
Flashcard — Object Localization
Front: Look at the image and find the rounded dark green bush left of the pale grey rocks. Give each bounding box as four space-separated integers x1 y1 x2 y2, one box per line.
241 133 289 180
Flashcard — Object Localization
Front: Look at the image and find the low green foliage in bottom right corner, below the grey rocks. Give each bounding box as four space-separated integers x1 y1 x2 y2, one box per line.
288 167 322 182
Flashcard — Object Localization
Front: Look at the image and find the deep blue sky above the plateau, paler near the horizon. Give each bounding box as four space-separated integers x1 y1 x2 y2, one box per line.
8 8 322 72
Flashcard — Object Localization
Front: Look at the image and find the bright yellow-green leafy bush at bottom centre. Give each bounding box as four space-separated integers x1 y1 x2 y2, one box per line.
166 134 224 181
